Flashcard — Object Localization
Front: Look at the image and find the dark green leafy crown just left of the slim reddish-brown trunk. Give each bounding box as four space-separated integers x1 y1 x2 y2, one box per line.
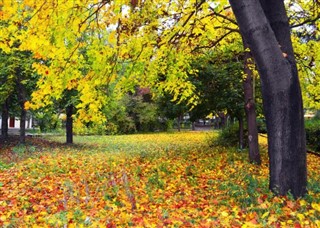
191 49 248 119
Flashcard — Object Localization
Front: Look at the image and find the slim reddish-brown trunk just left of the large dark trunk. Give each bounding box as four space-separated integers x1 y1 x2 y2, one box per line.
243 42 261 165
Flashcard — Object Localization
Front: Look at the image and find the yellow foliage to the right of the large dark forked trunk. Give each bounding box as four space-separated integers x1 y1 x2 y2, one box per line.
288 0 320 110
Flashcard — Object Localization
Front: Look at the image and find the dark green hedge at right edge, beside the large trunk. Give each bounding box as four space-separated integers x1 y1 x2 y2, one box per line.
305 118 320 151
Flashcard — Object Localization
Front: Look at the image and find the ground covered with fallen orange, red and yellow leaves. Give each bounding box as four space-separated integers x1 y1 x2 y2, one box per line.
0 132 320 227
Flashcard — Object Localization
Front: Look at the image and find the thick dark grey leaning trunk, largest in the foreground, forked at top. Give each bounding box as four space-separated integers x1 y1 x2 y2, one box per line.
230 0 307 197
